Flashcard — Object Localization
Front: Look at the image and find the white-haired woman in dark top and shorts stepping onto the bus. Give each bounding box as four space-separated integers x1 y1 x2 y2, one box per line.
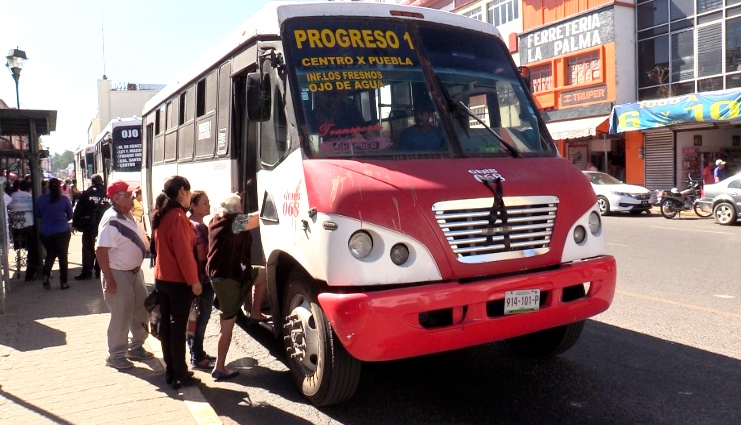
206 194 271 381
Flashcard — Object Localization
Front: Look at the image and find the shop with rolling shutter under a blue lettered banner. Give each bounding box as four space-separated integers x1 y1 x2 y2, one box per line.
610 89 741 189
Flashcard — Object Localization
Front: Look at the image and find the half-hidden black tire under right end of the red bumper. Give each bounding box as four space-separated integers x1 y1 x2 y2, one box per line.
507 320 584 358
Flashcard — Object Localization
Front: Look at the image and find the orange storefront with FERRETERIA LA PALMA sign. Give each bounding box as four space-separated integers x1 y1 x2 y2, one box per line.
518 3 635 180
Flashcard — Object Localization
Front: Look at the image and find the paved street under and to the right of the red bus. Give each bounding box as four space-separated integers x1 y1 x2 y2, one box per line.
197 214 741 425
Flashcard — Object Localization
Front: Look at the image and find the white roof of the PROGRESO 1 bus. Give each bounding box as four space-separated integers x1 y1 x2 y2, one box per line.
142 1 501 116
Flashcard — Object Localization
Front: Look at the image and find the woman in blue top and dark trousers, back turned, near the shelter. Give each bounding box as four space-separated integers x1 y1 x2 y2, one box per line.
36 178 72 289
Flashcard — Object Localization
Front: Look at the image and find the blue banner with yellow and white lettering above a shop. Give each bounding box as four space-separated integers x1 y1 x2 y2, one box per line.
610 89 741 134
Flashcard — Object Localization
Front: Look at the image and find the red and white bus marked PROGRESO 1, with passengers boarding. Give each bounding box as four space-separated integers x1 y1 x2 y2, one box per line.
142 2 616 405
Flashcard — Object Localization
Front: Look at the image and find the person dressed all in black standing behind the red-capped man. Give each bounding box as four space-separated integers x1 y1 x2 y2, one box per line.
72 174 111 280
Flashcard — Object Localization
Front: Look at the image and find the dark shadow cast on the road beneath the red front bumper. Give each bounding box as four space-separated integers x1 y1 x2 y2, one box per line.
310 321 741 425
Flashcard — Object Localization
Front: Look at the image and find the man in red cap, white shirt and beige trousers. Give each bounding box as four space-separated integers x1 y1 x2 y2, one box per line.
95 180 154 369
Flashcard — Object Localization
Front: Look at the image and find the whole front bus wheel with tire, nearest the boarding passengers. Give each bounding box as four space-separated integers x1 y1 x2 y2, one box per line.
282 270 361 406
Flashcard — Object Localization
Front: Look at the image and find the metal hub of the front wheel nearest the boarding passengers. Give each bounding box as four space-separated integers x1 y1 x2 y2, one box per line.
283 298 319 375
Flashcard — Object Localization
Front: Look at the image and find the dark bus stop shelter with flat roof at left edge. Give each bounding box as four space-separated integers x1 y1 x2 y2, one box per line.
0 109 57 314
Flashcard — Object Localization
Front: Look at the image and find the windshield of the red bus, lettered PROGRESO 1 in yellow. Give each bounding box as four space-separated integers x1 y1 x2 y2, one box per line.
285 18 557 158
